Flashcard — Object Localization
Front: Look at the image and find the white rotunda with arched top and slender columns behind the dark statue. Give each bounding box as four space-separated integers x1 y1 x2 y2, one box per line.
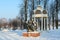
32 5 48 30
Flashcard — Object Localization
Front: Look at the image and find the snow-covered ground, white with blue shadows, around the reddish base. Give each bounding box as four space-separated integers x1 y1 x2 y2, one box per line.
0 28 60 40
